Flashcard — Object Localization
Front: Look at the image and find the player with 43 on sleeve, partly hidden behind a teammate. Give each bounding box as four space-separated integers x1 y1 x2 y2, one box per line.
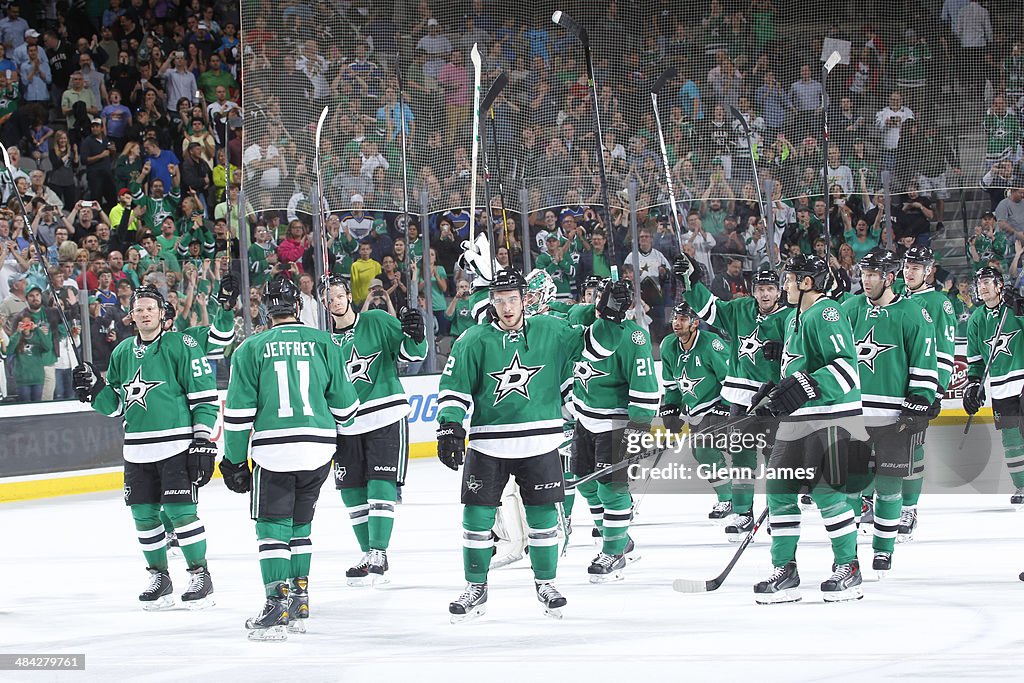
896 247 956 543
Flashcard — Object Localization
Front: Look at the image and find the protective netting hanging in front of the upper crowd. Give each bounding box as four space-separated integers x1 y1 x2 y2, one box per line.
242 0 1024 278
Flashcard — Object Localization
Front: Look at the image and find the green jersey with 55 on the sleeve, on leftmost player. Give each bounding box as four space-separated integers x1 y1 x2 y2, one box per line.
92 332 218 463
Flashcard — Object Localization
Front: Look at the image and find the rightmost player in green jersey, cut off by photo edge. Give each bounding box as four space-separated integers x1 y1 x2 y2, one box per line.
964 266 1024 506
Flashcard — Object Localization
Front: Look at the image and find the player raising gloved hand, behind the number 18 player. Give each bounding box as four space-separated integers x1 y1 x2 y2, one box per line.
673 254 792 540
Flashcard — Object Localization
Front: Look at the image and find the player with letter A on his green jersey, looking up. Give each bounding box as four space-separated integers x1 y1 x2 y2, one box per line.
658 301 741 540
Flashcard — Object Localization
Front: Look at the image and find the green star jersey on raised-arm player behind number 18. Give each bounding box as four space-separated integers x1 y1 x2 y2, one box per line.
684 283 794 407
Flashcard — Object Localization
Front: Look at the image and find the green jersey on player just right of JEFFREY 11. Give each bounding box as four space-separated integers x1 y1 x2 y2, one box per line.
336 310 427 434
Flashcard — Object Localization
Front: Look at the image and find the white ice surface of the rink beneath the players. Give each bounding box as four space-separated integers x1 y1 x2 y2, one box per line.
0 460 1024 683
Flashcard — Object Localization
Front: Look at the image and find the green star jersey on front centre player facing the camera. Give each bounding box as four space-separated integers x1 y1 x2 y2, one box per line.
437 315 582 459
